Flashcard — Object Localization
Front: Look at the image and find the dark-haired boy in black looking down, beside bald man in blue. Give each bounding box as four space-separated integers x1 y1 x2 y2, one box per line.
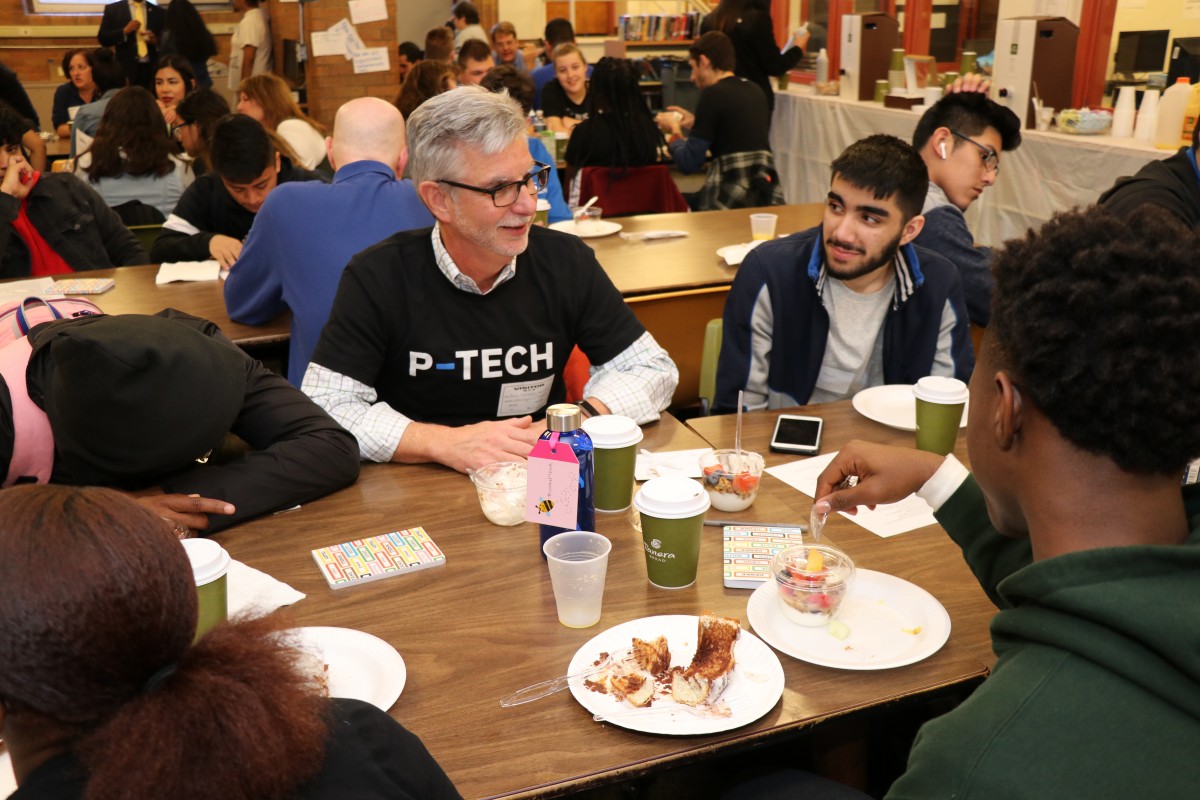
150 114 324 267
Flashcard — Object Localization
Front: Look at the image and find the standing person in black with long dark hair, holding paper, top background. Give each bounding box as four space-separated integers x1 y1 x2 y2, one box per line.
700 0 809 110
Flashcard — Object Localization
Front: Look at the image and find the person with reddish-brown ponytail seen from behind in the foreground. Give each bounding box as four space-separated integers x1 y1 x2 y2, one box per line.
0 486 458 800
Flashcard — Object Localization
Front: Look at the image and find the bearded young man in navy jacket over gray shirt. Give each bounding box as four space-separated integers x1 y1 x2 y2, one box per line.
715 134 974 410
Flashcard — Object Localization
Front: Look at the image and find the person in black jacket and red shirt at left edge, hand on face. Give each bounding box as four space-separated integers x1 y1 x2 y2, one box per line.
0 106 150 278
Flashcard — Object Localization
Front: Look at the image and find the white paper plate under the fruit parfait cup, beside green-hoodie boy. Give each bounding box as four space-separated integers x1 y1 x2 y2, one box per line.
746 570 950 669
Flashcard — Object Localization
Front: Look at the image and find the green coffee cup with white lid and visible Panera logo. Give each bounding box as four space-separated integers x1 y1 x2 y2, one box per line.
634 477 709 589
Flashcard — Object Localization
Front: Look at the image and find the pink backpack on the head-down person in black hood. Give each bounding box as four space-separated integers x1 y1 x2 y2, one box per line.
0 297 104 487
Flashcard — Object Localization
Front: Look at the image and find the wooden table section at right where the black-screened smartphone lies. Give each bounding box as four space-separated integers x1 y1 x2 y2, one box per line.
688 401 996 667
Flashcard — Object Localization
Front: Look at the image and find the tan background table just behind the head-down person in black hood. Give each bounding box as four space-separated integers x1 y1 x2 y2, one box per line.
5 264 292 347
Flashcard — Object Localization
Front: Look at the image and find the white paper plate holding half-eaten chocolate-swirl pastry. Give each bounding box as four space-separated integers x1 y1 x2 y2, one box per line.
566 614 784 736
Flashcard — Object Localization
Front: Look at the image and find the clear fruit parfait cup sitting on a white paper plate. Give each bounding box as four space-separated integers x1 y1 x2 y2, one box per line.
770 545 854 627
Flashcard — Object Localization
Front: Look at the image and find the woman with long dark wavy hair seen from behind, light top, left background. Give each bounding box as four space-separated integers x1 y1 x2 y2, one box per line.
74 86 196 219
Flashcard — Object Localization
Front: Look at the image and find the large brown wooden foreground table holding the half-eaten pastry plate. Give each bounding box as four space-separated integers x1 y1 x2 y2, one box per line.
216 416 986 799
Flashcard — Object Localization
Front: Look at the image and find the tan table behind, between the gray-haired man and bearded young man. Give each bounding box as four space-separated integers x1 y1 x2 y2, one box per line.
586 203 824 408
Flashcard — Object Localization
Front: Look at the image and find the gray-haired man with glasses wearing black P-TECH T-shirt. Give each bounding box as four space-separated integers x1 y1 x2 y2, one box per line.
304 86 679 471
